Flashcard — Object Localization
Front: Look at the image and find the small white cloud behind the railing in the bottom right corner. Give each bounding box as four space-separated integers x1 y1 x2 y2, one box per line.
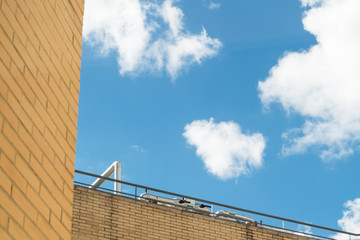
332 198 360 239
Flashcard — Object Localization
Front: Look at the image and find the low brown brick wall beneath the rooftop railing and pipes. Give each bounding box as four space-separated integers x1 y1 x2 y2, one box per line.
72 186 308 240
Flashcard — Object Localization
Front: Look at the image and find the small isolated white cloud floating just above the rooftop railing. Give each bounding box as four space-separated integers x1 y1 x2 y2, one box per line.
183 118 265 179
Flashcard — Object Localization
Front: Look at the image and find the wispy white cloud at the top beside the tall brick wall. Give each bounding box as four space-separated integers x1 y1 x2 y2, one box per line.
83 0 222 78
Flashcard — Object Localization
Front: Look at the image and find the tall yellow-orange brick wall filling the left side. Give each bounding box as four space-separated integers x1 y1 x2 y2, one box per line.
0 0 84 240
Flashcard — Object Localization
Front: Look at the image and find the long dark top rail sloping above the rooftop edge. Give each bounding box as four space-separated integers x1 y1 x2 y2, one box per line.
75 170 360 239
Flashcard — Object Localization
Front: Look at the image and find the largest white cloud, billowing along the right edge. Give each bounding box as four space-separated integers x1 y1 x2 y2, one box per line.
258 0 360 160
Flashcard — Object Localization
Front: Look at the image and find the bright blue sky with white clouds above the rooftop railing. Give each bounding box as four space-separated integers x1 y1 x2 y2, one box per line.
76 0 360 236
